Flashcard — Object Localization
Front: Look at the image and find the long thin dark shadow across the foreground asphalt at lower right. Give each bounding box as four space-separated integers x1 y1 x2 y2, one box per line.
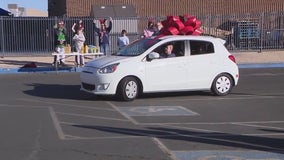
72 125 284 154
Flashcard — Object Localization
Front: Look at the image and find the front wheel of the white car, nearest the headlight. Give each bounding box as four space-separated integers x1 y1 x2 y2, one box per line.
117 77 139 101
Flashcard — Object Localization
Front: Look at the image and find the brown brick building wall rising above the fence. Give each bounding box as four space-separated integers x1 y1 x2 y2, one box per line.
49 0 284 17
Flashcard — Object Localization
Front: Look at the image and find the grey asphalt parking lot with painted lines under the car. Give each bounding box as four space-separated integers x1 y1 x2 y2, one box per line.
0 68 284 160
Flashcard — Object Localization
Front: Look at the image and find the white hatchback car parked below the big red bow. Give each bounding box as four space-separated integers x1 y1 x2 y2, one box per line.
80 35 239 101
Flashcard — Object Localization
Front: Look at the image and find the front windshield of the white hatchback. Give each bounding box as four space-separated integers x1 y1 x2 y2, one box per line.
116 37 160 56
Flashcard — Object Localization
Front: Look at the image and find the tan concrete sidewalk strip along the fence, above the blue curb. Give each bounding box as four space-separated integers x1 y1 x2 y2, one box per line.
0 51 284 70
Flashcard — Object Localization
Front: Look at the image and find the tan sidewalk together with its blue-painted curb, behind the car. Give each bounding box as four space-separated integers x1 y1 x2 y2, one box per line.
0 51 284 74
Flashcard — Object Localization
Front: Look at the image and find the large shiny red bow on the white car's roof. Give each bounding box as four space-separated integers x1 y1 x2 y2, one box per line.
161 14 202 35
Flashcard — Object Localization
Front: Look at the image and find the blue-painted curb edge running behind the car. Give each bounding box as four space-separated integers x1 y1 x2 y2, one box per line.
0 63 284 74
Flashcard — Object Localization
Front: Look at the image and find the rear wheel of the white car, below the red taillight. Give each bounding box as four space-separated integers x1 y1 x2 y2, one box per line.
211 73 233 96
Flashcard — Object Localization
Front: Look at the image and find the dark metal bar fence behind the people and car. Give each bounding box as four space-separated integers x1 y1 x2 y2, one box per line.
0 12 284 56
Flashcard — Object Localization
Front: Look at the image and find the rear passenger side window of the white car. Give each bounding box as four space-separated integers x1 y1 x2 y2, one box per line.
190 40 214 55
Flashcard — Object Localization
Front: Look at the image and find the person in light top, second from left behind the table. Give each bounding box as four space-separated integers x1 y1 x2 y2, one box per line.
72 28 86 66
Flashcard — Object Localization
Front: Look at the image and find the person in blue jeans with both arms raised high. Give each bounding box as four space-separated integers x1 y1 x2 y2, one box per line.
93 17 112 56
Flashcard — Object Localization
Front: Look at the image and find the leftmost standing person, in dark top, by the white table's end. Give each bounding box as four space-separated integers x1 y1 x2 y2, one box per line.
53 21 67 65
